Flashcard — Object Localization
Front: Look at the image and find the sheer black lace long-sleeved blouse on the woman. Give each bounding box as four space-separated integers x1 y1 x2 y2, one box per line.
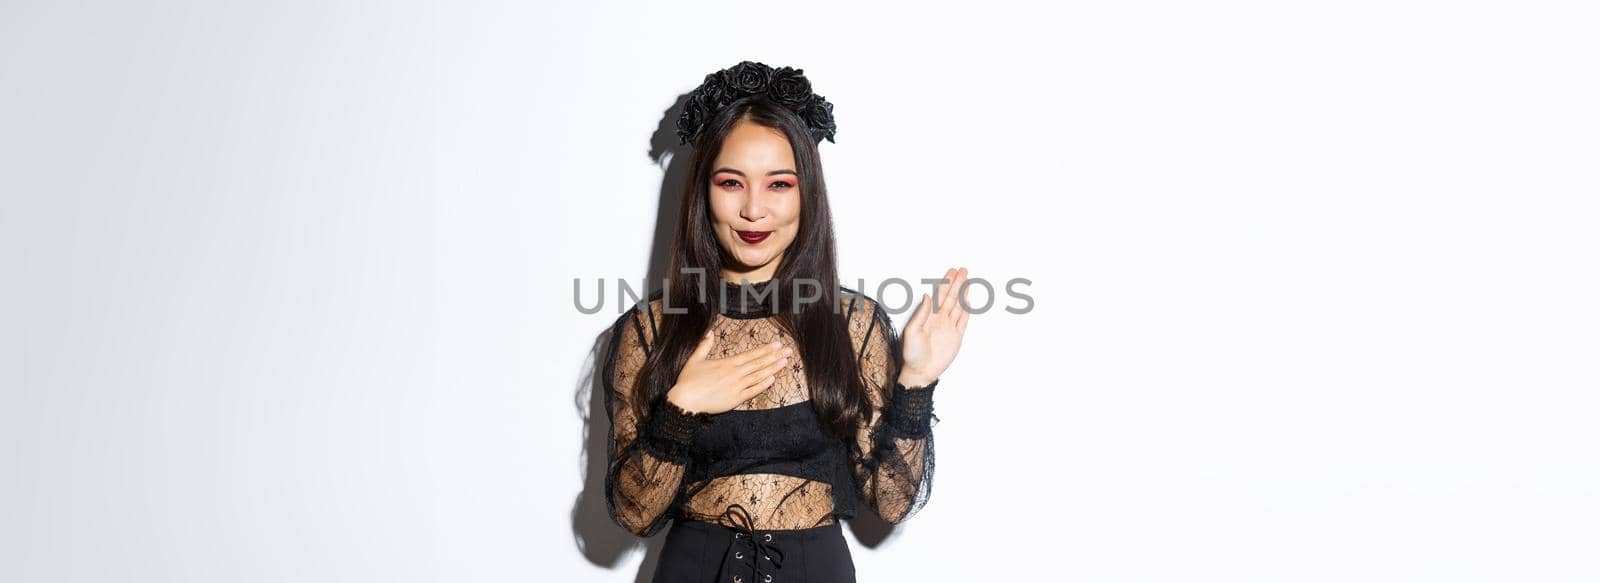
602 280 938 537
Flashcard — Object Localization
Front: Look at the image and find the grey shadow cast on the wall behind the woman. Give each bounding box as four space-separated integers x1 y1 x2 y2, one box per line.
571 93 894 583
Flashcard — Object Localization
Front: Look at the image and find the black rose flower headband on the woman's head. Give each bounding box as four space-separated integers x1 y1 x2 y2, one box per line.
678 61 837 144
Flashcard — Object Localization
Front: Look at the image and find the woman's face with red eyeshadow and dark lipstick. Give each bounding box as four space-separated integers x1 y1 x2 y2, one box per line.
710 120 800 282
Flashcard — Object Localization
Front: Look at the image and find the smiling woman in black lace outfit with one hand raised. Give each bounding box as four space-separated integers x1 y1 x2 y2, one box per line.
603 61 968 583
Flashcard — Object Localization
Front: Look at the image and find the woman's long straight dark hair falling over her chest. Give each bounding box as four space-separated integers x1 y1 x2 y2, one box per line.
634 96 872 444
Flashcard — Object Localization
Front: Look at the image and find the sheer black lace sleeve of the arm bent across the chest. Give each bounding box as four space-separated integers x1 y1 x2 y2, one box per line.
603 304 709 537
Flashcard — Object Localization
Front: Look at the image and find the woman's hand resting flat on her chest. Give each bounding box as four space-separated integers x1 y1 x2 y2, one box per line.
667 332 794 413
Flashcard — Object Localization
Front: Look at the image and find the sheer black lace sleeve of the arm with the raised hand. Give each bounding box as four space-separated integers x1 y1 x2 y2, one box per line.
850 296 939 524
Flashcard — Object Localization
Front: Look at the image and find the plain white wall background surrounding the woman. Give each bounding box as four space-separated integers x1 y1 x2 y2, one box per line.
0 0 1600 581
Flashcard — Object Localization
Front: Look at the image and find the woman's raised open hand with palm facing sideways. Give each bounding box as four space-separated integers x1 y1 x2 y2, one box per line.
899 267 971 388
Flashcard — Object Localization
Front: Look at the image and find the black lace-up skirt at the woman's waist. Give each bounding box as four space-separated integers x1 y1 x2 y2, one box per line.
651 505 856 583
